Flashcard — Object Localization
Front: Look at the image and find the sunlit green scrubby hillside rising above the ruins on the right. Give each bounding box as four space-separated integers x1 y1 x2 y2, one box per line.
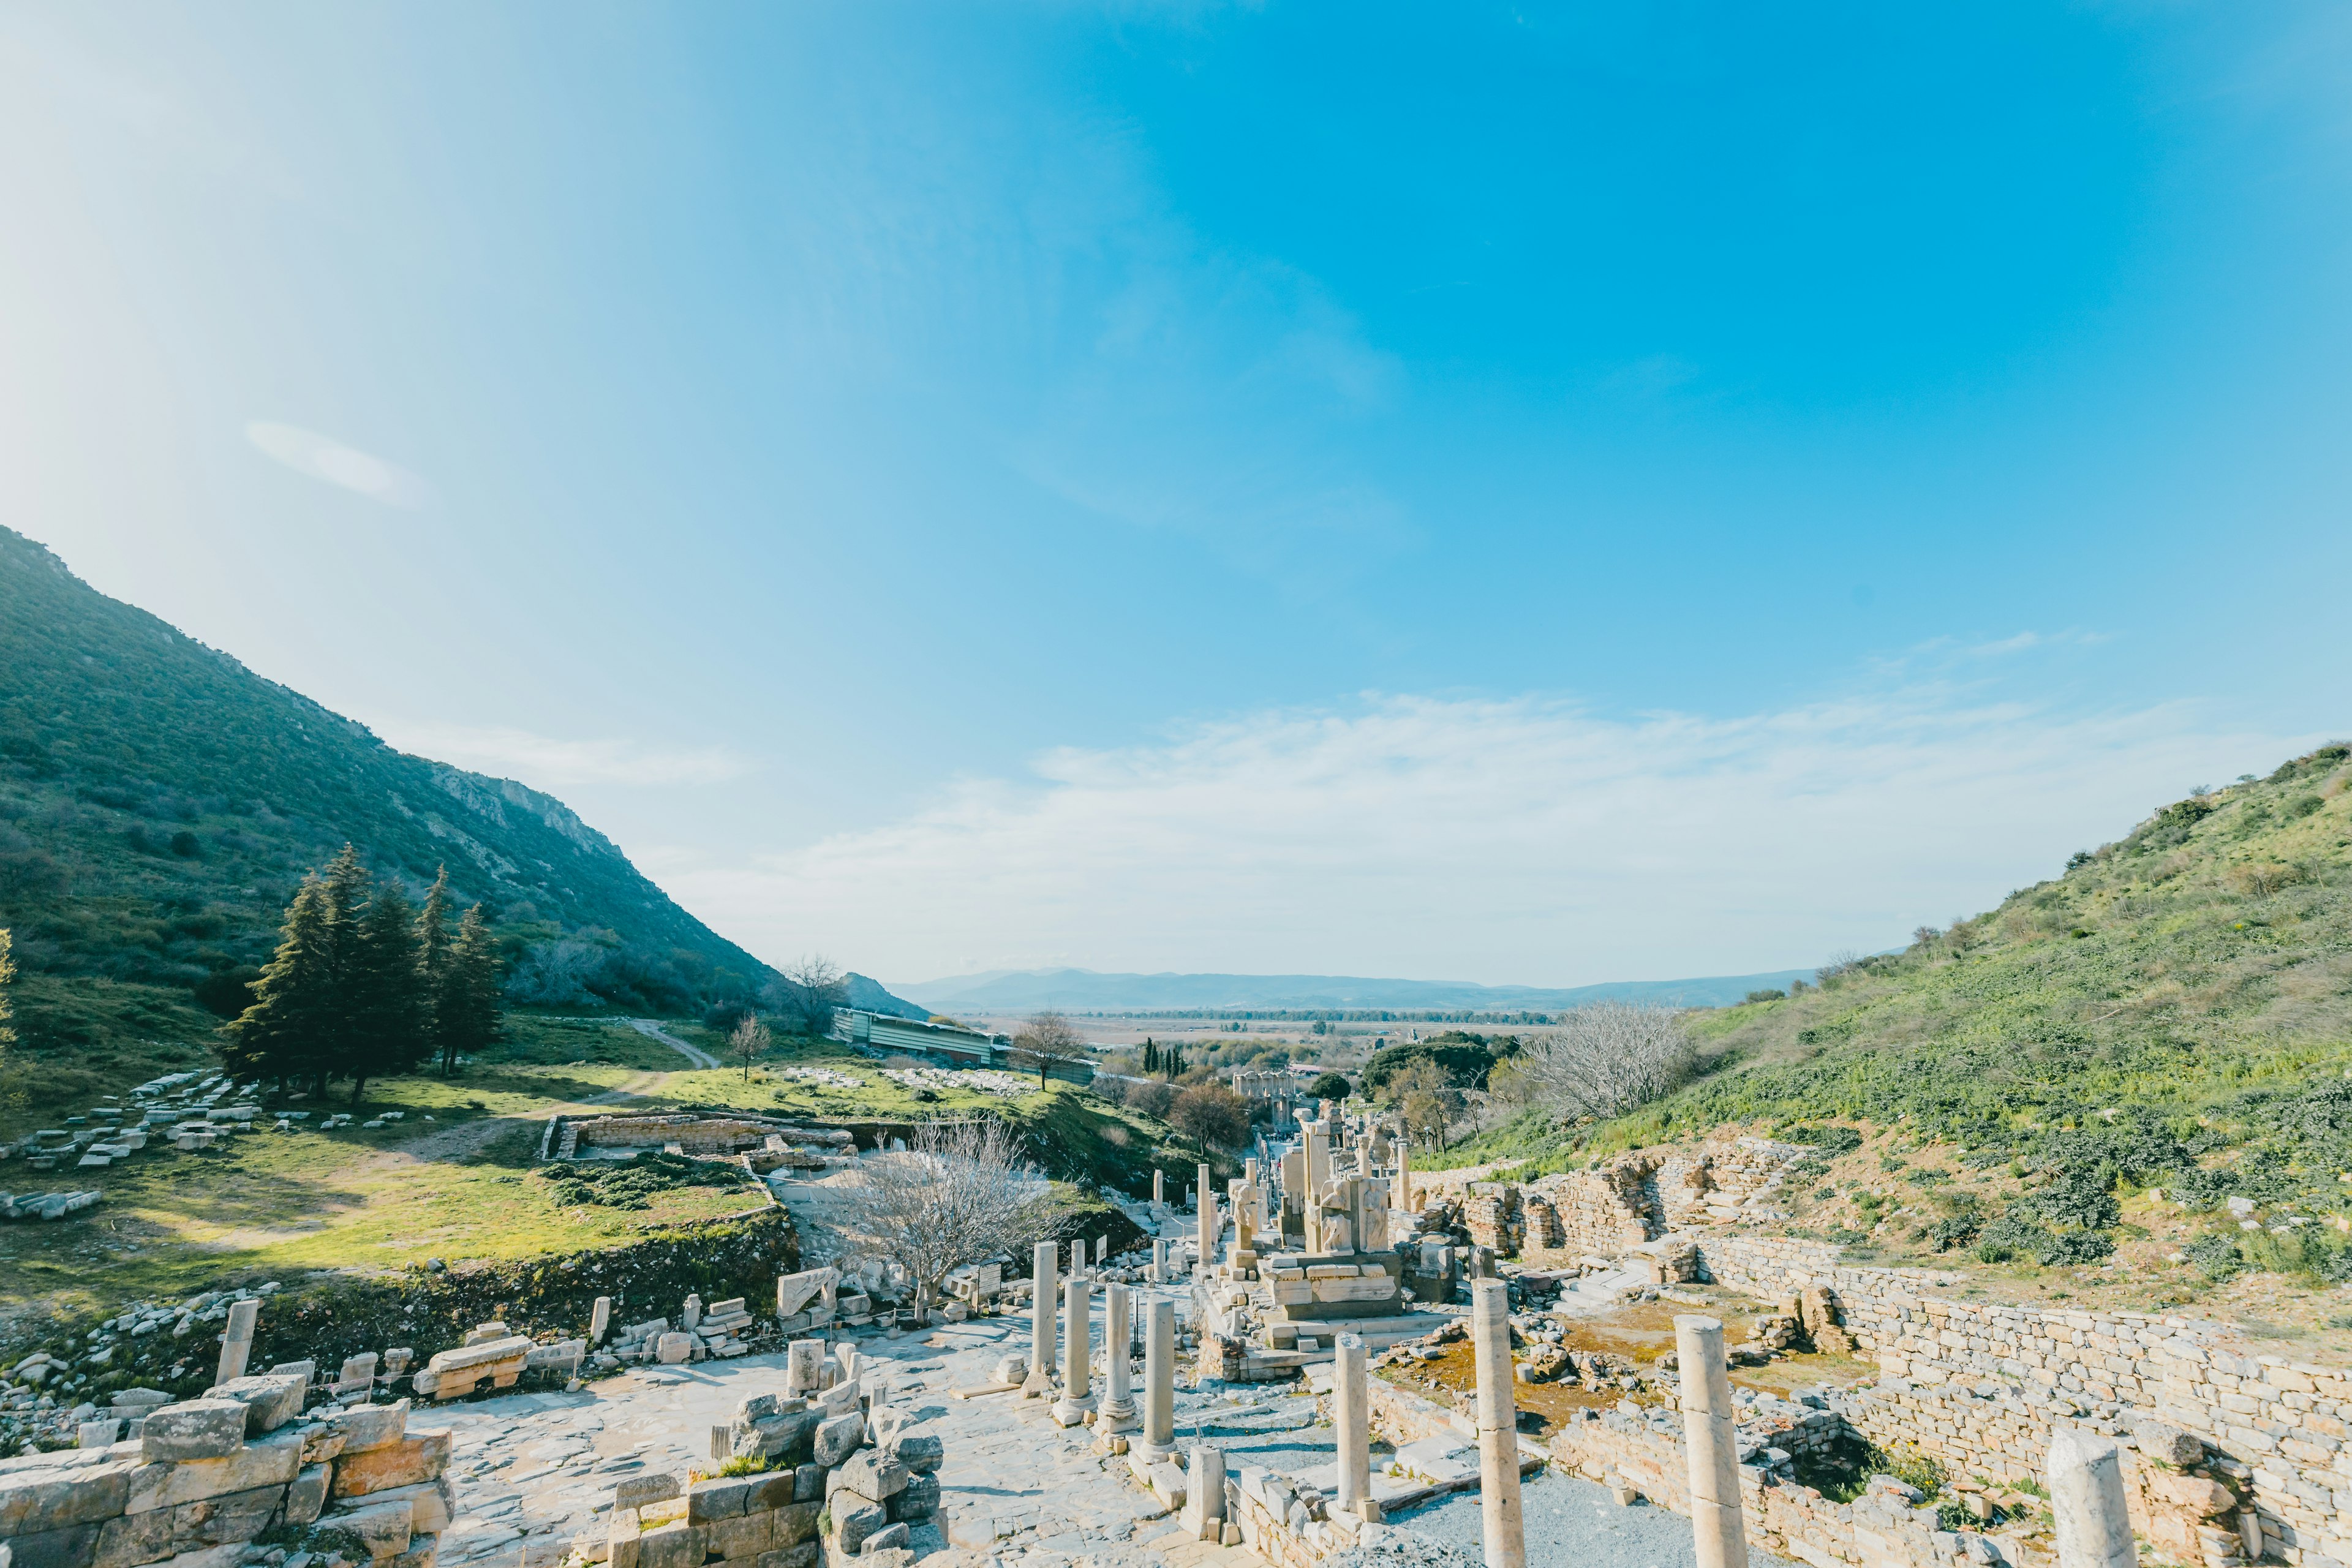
1461 745 2352 1267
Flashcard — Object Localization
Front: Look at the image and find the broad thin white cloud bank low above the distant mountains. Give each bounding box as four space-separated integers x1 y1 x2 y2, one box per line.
670 689 2310 985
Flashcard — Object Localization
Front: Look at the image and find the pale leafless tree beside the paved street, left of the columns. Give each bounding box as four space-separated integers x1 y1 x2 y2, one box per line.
856 1119 1051 1316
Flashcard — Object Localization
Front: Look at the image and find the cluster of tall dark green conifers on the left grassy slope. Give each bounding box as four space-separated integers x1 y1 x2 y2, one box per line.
221 844 503 1105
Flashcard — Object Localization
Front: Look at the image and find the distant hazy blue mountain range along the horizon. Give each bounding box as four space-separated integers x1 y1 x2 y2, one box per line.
891 968 1814 1013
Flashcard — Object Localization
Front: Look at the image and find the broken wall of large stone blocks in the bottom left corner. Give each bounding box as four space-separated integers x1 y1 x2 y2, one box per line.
0 1368 454 1568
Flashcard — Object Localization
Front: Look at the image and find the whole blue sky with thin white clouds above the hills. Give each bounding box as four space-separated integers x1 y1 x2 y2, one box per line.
0 5 2352 985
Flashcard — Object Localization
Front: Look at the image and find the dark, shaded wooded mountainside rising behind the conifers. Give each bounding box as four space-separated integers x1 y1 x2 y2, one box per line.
0 529 769 1030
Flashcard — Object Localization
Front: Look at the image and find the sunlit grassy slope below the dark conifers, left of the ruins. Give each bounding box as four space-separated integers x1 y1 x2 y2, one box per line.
0 1020 1193 1319
